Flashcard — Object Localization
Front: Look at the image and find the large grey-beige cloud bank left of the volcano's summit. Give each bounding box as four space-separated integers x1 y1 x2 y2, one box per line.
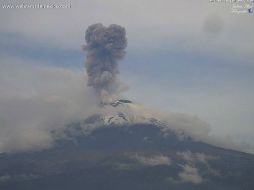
0 58 97 152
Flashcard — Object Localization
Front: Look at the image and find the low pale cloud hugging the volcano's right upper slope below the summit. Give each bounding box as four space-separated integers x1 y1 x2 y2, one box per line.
125 104 254 154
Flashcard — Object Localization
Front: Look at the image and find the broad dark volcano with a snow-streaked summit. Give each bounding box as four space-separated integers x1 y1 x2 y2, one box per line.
0 99 254 190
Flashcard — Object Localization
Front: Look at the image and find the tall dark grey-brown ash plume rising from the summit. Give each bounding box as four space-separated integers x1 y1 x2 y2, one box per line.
84 24 127 103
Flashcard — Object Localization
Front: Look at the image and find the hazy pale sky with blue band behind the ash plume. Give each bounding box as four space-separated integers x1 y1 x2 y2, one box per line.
0 0 254 151
